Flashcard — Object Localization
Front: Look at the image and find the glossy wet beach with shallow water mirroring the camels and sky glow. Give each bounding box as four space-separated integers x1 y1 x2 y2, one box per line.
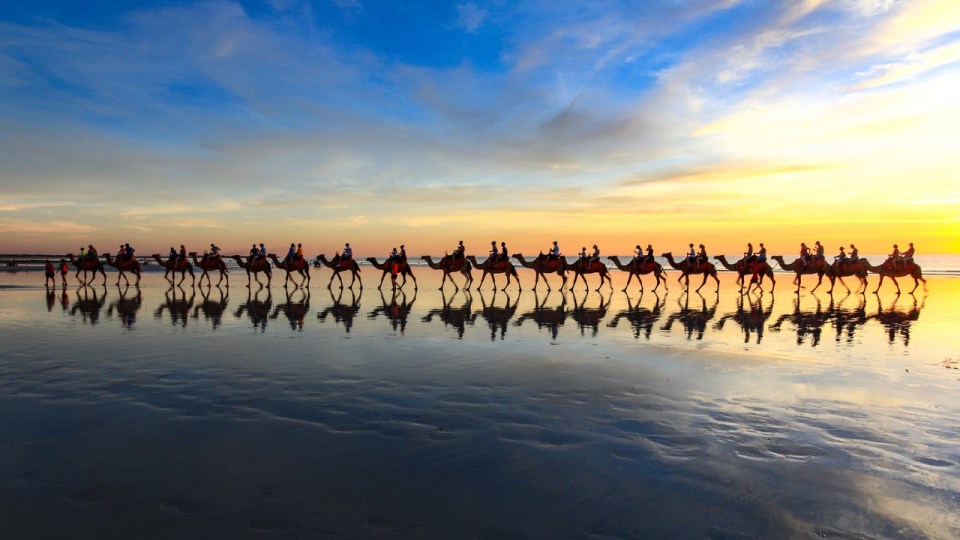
0 268 960 538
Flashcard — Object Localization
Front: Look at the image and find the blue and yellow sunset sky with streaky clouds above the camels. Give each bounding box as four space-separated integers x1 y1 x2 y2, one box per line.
0 0 960 257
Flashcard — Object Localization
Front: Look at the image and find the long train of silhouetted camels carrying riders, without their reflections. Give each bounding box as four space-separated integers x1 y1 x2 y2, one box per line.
58 241 926 294
